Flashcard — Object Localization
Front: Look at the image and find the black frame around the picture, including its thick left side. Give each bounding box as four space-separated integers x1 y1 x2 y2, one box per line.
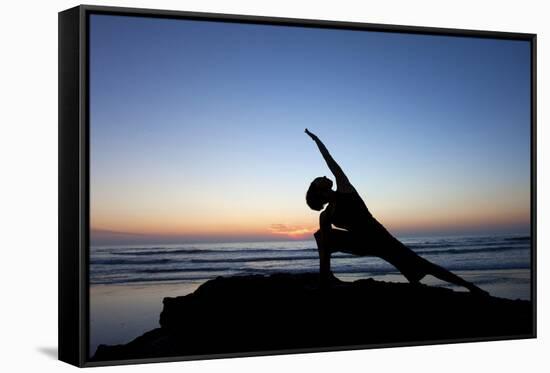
58 5 537 367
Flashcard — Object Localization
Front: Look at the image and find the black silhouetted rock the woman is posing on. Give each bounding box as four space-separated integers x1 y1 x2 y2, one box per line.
93 274 533 360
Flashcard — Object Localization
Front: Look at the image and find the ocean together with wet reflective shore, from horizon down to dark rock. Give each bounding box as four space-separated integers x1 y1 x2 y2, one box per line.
90 235 531 354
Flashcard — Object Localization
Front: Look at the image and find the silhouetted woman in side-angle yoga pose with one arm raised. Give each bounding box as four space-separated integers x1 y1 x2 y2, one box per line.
305 129 488 294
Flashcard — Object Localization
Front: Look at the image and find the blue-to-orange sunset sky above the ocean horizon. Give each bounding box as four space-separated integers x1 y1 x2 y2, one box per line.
89 15 530 244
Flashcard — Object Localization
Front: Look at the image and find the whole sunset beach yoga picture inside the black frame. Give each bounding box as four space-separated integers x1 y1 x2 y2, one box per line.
88 14 533 361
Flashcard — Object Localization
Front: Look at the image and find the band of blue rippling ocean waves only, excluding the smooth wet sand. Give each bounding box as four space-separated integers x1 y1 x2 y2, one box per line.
90 232 531 285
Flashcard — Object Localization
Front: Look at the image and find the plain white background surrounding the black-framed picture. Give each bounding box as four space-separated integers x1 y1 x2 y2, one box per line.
0 0 550 373
